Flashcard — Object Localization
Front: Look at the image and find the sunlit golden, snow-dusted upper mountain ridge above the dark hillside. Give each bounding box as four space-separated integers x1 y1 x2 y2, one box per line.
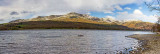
1 12 154 30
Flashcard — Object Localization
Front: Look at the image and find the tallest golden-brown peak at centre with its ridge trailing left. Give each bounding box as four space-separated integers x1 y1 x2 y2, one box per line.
9 12 100 23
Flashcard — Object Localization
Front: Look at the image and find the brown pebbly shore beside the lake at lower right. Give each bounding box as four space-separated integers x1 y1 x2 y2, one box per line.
126 34 160 54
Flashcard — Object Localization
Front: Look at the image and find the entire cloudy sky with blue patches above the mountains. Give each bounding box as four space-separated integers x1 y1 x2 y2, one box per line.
0 0 158 23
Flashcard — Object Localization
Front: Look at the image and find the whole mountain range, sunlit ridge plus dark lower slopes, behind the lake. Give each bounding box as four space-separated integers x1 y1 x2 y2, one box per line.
3 12 153 30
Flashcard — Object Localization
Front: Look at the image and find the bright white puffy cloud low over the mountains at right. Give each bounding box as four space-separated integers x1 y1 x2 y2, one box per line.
116 9 157 23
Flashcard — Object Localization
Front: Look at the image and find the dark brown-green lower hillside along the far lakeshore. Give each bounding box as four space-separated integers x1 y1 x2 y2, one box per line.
0 21 129 30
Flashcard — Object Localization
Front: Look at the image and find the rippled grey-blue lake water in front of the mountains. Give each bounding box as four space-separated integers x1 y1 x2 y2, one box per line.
0 29 152 54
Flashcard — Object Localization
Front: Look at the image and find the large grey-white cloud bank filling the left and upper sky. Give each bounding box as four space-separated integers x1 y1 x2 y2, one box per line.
0 0 152 22
